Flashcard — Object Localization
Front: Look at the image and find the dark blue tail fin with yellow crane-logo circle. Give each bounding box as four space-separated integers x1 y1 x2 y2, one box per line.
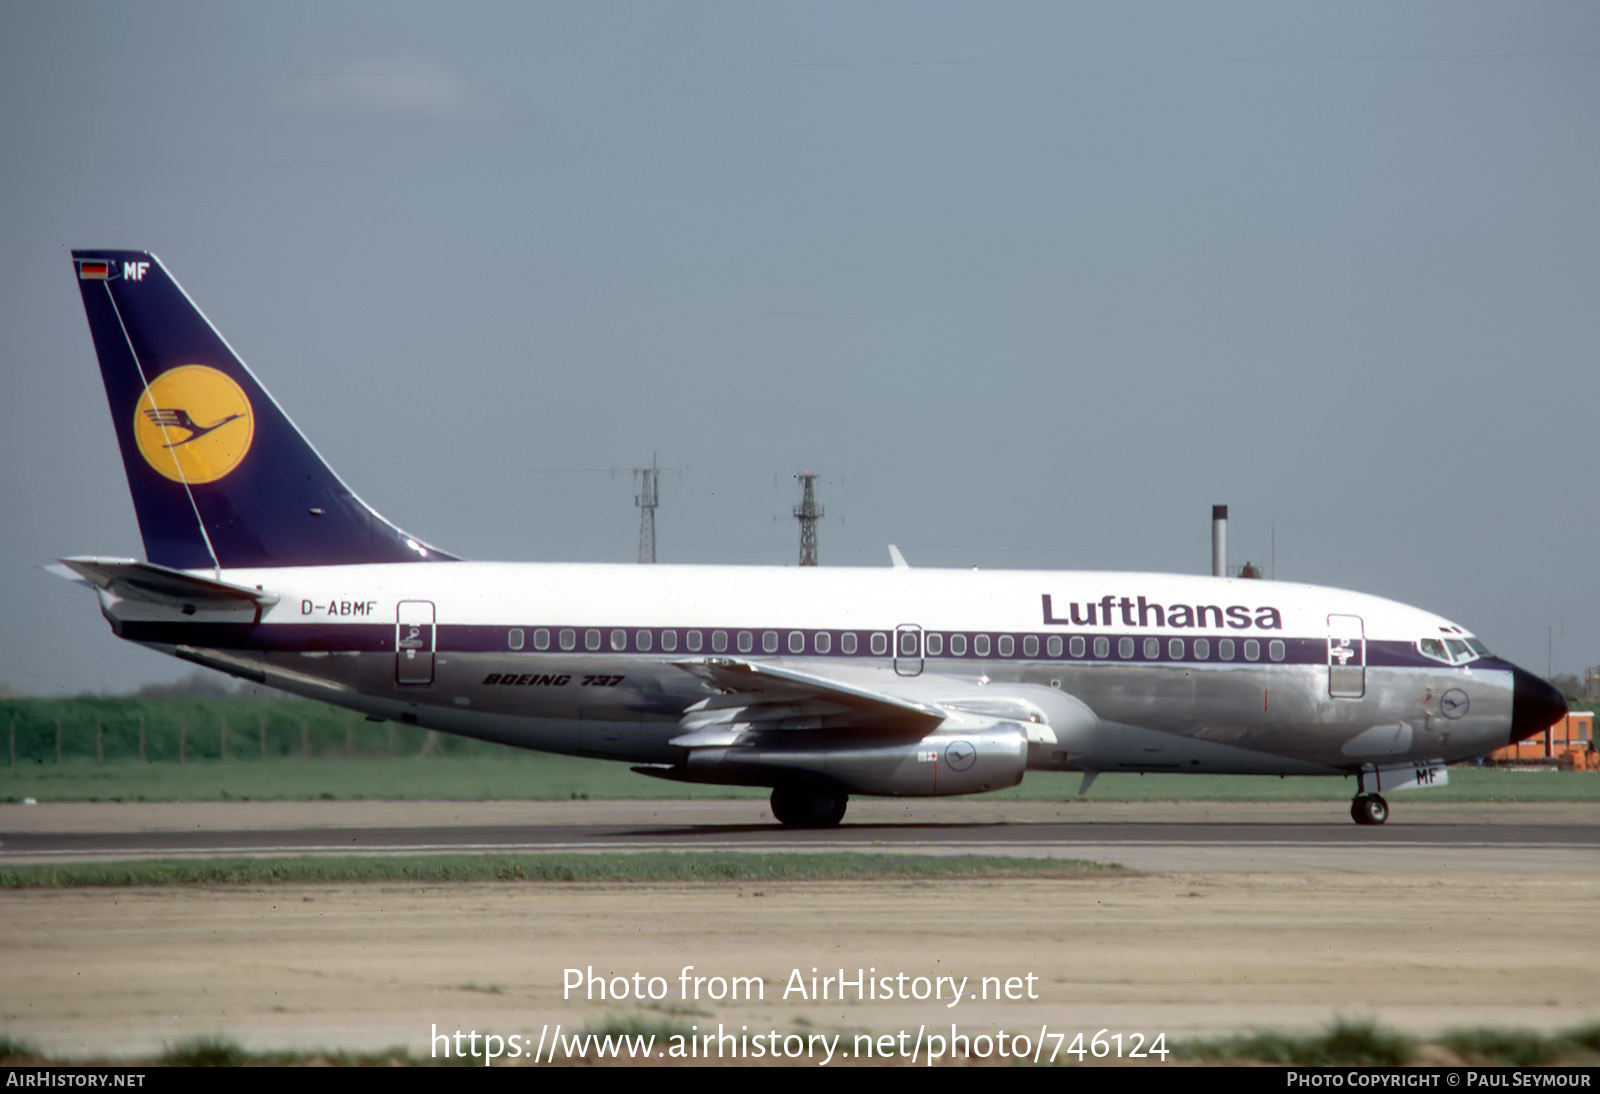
72 251 454 569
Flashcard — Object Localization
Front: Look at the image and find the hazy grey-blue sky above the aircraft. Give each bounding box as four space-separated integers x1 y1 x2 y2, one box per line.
0 0 1600 696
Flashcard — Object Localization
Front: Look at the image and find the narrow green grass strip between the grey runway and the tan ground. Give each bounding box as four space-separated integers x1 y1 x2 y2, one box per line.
0 851 1123 889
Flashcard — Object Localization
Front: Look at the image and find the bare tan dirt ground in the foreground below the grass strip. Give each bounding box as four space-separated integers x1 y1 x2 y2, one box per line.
0 872 1600 1056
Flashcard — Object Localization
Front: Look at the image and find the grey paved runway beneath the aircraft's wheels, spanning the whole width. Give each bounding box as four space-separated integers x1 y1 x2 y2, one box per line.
0 801 1600 873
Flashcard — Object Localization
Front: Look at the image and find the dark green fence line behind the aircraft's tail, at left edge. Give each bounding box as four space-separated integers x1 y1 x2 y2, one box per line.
0 697 490 768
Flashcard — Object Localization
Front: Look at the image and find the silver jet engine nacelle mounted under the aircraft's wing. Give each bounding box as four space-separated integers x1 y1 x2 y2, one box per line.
675 715 1027 798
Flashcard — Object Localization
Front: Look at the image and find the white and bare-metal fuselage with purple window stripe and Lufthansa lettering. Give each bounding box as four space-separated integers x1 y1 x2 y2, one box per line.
102 561 1514 774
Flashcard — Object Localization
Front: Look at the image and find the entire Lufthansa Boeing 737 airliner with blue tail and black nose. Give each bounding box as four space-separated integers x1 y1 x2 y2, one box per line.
58 251 1566 827
